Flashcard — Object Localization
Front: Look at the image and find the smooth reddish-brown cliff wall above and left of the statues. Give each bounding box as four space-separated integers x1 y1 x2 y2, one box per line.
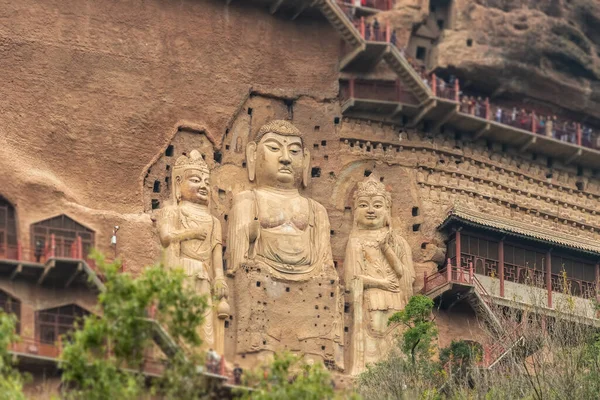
0 0 339 270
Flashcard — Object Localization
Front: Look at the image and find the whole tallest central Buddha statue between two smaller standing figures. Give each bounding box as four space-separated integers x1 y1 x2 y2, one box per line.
227 120 343 369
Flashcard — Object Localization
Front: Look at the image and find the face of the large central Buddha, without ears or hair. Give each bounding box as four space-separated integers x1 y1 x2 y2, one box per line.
256 133 305 189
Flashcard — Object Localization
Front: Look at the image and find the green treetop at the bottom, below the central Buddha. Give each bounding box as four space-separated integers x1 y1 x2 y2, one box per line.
239 353 356 400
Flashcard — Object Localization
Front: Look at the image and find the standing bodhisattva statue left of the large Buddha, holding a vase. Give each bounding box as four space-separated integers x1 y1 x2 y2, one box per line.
158 150 229 354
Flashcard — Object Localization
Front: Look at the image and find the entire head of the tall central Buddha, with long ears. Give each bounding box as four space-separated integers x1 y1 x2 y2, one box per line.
246 120 310 189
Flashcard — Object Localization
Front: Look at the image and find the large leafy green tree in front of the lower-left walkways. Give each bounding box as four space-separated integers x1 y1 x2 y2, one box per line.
61 254 207 400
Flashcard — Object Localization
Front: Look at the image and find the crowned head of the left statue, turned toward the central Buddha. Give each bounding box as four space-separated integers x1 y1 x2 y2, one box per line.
173 150 210 204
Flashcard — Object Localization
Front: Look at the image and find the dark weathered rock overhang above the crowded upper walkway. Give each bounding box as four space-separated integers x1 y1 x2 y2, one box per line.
382 0 600 118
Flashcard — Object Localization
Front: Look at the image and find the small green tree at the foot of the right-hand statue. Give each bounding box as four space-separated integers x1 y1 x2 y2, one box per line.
388 295 437 364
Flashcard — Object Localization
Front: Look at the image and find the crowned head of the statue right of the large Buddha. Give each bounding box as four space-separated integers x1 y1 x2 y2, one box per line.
354 176 392 229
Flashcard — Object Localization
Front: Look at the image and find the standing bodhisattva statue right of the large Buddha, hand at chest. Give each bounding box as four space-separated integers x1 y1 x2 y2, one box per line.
344 176 415 374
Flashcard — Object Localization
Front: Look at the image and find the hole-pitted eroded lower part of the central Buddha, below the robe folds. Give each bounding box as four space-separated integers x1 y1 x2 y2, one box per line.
236 265 344 370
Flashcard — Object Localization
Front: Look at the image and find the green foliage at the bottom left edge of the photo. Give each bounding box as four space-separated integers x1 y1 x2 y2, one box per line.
0 310 25 400
